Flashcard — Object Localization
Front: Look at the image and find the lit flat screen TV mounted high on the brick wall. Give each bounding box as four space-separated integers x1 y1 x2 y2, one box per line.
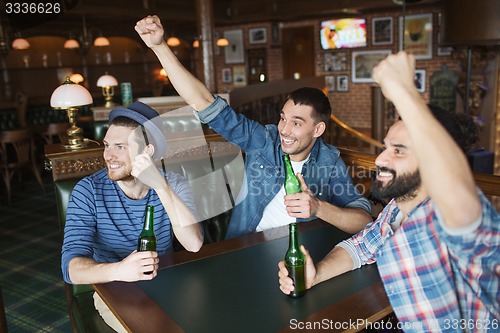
320 18 366 50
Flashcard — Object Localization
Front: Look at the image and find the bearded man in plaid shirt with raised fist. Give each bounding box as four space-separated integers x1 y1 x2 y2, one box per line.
278 52 500 332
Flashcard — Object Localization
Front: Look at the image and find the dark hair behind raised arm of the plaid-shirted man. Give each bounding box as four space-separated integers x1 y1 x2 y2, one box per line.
428 104 480 154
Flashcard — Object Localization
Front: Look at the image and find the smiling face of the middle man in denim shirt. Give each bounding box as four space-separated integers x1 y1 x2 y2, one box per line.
278 99 325 162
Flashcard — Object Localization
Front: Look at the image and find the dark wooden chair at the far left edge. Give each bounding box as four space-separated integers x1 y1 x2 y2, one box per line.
0 129 45 204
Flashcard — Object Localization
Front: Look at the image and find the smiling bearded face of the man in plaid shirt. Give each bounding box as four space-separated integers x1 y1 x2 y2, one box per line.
372 121 421 202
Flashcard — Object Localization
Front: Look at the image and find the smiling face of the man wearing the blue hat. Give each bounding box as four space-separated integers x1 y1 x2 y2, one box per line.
103 125 143 181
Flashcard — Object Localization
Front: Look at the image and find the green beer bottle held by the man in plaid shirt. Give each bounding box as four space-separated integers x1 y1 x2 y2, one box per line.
285 223 306 298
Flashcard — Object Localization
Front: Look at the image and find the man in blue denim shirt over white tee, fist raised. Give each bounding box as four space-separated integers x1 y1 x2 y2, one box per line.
135 16 371 238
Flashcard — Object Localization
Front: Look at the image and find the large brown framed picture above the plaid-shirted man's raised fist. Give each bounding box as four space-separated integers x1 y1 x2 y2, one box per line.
399 13 432 60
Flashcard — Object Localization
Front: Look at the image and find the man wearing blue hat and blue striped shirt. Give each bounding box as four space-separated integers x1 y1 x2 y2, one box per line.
61 102 203 330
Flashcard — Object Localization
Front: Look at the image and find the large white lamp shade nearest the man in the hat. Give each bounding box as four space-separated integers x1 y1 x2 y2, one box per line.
50 78 93 109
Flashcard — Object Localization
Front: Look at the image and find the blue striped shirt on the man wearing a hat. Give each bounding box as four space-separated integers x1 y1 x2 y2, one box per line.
61 168 197 283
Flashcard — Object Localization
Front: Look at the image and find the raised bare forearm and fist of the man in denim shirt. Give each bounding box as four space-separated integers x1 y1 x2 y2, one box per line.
135 15 214 111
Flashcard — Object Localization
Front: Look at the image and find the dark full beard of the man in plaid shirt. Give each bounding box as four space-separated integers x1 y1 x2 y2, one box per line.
371 167 422 202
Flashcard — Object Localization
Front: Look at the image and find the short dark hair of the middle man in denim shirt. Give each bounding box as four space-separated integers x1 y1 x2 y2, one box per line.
287 87 332 124
